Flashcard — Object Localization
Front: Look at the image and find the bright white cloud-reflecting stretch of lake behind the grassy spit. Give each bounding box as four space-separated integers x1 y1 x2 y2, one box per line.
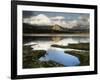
24 36 89 50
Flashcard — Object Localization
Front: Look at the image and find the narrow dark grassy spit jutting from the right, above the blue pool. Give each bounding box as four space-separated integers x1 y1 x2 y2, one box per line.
51 43 89 50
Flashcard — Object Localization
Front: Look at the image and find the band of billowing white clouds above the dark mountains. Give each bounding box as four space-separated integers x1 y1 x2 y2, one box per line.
23 14 89 28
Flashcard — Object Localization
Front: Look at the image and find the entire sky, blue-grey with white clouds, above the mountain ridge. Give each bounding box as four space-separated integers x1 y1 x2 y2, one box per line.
23 11 89 28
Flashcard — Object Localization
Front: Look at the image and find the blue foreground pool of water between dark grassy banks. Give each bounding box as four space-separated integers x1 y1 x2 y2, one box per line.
40 48 80 66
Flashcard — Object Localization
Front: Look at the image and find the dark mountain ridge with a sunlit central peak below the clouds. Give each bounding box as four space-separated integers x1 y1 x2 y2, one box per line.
23 23 89 33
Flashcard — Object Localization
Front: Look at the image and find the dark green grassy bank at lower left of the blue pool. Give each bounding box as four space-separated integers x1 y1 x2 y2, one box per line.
23 46 63 68
